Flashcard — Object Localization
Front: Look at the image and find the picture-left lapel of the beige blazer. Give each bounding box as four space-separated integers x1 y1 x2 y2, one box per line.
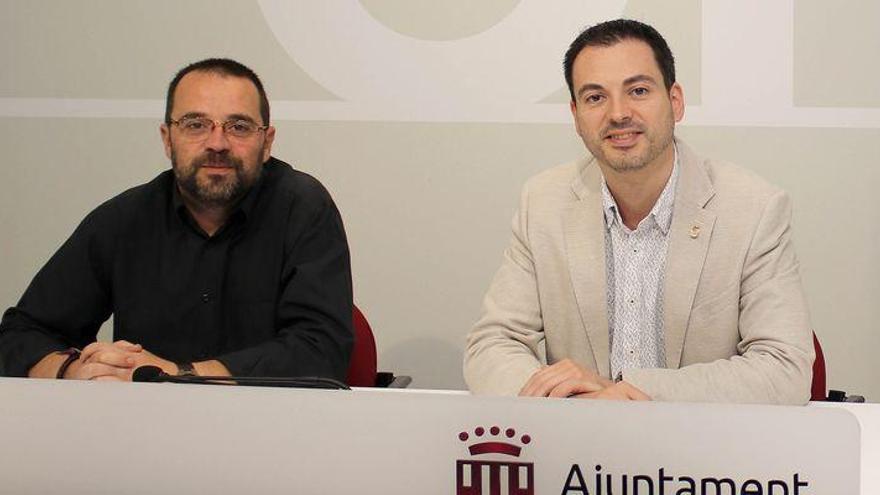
563 160 611 377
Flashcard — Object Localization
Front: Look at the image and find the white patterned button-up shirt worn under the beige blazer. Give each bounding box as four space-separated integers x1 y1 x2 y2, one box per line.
602 150 679 377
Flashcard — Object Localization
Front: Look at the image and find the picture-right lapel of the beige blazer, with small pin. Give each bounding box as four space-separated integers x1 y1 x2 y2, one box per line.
663 141 715 369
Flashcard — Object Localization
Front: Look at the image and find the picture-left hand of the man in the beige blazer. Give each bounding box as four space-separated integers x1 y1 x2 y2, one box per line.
519 358 614 397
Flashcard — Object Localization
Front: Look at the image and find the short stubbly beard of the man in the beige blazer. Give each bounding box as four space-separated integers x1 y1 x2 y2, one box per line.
584 116 675 173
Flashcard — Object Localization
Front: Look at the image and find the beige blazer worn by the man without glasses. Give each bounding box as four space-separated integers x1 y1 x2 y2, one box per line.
464 141 814 404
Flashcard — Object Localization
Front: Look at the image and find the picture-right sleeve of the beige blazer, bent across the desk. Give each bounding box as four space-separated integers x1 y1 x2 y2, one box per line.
623 191 815 405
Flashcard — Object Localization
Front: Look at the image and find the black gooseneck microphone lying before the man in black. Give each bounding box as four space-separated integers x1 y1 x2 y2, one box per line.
131 366 351 390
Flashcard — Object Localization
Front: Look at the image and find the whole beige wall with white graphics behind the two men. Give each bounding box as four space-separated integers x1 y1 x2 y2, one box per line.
0 0 880 400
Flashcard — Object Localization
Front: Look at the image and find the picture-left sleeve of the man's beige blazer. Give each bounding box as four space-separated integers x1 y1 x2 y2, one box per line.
464 182 544 395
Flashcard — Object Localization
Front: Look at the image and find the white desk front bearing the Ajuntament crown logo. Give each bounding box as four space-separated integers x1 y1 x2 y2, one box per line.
0 378 880 495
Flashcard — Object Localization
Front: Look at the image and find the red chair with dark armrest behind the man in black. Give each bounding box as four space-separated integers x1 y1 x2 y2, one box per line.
347 306 412 388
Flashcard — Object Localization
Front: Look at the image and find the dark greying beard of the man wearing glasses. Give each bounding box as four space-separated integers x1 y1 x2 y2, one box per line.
171 147 263 208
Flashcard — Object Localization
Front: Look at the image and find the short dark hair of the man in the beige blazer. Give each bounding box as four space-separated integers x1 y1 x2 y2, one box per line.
562 19 675 101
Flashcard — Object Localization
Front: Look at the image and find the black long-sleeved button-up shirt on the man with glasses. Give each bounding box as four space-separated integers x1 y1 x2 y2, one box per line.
0 158 353 380
